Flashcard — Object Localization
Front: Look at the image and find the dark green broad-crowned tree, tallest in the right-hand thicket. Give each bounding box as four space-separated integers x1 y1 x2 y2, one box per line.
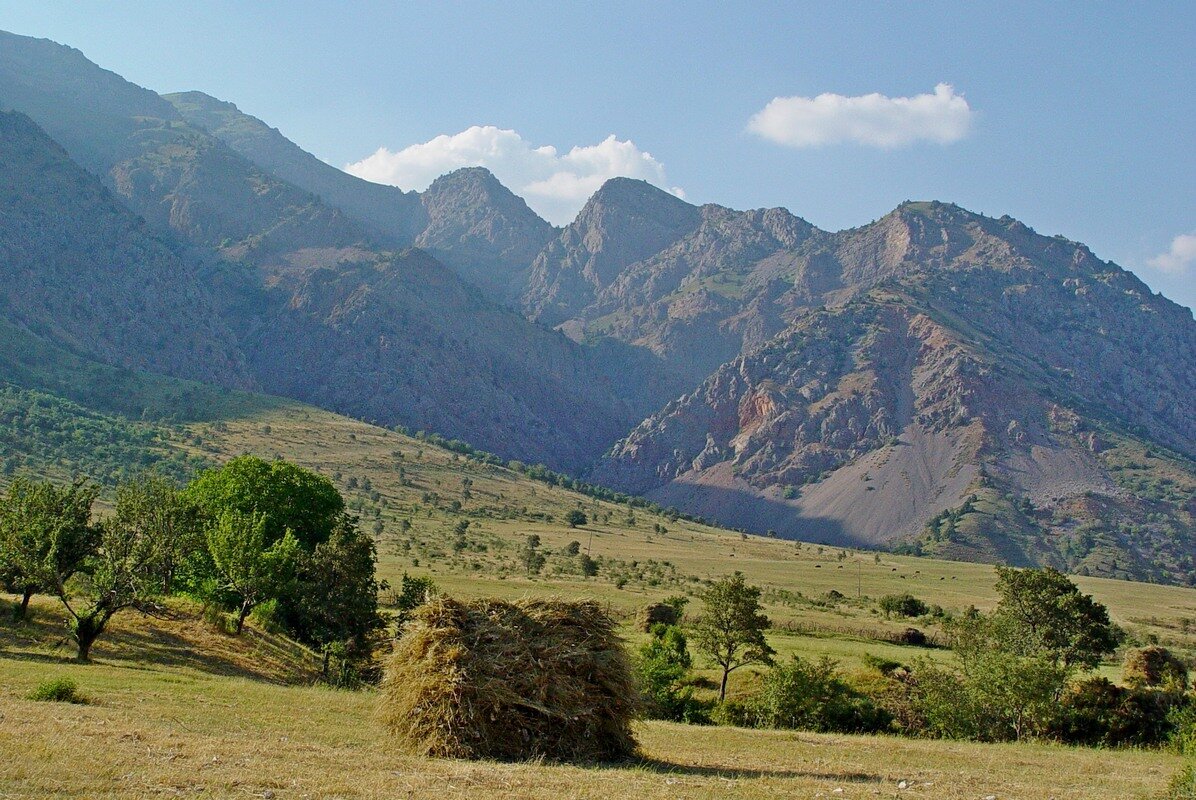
994 567 1118 670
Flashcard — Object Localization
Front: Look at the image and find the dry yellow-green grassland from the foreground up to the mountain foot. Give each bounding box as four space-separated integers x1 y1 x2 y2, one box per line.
7 391 1196 800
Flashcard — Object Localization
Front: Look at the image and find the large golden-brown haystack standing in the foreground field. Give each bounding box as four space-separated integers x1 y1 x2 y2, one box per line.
380 598 636 762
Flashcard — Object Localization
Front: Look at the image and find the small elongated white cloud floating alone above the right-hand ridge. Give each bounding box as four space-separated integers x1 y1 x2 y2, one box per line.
748 84 972 148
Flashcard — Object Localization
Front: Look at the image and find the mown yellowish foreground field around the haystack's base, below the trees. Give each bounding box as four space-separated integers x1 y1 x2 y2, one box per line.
0 604 1180 800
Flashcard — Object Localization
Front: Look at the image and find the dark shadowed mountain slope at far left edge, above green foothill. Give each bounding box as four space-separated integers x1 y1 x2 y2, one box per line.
0 112 252 386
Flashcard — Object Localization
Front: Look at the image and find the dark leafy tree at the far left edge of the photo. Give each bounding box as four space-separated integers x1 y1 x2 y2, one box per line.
0 477 98 618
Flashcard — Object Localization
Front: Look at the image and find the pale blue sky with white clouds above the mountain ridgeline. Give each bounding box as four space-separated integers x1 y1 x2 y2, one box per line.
0 0 1196 307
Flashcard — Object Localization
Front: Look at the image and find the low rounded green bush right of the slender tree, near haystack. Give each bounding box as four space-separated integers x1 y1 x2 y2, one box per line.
744 655 892 733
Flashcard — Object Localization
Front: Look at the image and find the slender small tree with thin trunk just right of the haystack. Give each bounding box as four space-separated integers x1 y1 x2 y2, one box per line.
694 572 776 702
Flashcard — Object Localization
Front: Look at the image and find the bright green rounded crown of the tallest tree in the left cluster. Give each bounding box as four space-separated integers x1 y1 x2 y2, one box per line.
184 456 344 552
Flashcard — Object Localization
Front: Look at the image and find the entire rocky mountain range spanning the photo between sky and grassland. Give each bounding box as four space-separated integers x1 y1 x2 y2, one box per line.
0 33 1196 580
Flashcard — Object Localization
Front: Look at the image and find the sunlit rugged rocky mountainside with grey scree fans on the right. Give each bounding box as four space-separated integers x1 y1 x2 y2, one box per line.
593 261 1196 580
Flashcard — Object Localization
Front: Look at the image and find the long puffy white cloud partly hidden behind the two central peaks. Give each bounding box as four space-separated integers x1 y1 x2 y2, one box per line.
344 126 684 225
